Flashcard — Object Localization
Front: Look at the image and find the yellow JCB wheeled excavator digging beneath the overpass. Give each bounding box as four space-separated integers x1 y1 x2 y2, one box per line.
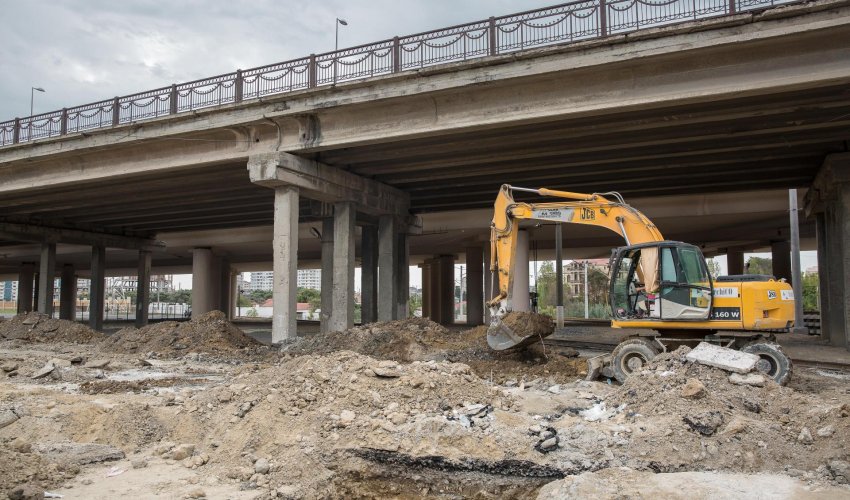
487 184 794 384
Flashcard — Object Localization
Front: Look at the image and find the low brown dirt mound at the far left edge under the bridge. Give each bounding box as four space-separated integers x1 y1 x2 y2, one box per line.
0 312 103 344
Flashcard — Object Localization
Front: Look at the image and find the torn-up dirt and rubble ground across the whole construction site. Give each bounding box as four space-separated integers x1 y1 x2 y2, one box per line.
0 312 850 499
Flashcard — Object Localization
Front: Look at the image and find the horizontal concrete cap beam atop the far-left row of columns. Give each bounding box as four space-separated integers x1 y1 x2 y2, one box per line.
0 222 165 250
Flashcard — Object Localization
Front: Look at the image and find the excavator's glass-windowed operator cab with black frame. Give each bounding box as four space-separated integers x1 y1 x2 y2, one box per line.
609 241 712 322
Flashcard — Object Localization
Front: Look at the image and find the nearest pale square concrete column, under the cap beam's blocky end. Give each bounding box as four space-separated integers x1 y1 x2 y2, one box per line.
272 186 298 343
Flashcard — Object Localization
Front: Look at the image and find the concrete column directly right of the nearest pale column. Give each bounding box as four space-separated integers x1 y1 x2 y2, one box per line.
328 202 356 332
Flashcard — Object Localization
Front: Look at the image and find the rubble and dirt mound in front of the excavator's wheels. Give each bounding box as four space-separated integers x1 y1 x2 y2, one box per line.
605 347 850 479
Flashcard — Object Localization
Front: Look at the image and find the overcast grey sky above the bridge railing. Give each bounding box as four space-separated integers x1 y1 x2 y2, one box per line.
0 0 558 121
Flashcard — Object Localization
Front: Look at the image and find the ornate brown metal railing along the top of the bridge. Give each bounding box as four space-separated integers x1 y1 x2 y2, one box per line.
0 0 801 146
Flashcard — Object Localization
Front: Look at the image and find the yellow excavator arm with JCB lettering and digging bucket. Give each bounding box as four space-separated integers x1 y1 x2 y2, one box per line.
488 184 664 349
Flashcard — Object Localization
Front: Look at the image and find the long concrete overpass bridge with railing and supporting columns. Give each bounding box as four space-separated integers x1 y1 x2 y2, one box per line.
0 0 850 345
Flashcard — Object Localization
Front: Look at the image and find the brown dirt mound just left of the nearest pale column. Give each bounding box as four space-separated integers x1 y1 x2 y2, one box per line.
104 311 268 357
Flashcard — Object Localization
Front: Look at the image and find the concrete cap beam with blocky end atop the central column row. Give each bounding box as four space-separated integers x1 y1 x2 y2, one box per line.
248 153 410 216
